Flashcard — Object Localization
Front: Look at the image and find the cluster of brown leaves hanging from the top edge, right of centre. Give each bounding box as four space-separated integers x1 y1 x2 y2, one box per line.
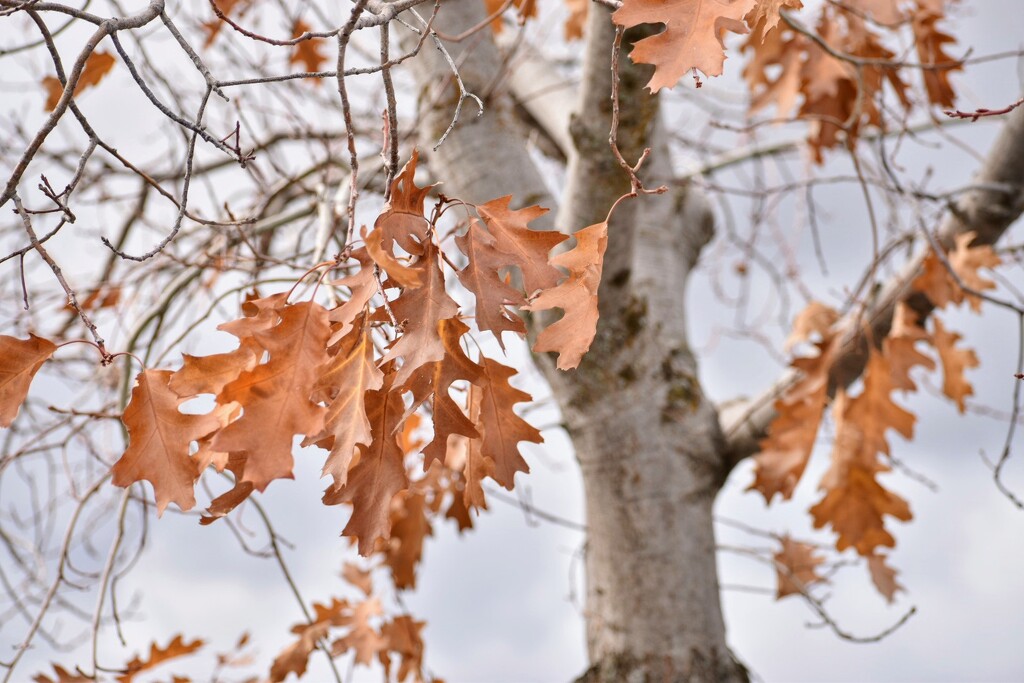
612 0 961 158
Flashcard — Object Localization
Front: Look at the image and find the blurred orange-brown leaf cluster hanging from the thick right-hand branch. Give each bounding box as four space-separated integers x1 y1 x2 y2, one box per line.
751 233 999 600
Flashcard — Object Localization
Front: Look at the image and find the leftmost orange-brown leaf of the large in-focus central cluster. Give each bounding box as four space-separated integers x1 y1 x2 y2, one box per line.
111 370 221 515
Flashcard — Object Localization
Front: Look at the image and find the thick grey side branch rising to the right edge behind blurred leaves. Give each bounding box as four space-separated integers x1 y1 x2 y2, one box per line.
723 109 1024 466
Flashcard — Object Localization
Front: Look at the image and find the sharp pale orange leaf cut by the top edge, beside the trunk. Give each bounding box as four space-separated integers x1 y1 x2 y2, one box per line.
611 0 755 92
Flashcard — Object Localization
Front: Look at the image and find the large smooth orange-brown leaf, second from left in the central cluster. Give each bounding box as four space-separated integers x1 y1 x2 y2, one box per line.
212 301 331 490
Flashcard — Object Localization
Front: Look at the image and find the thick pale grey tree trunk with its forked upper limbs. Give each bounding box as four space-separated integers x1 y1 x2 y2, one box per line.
403 0 746 682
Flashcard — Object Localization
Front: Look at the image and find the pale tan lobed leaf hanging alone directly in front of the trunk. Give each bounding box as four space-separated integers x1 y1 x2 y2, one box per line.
525 222 608 370
